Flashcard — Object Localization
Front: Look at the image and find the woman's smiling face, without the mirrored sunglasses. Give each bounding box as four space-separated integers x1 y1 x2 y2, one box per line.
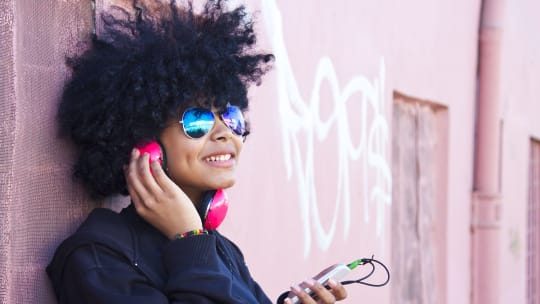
160 109 243 203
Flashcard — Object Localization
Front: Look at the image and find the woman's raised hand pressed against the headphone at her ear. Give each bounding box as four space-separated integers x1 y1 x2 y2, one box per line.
124 149 202 239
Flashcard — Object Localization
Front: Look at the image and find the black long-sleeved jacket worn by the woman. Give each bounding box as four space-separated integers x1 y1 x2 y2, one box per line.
47 206 271 304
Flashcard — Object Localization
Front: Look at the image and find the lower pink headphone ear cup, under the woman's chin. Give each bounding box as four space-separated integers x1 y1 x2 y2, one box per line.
198 189 229 230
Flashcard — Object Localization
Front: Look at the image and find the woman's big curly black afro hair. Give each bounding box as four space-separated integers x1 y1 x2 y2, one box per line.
58 0 273 199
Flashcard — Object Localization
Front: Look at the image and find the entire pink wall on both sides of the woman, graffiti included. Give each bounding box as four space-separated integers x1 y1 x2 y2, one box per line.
0 0 540 303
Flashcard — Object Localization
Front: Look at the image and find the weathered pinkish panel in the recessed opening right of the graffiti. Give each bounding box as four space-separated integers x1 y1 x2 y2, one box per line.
391 100 440 304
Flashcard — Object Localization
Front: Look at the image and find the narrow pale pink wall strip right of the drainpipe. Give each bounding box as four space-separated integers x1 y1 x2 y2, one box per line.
500 0 540 303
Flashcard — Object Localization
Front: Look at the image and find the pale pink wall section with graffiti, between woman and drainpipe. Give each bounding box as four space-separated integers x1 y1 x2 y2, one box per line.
224 0 480 303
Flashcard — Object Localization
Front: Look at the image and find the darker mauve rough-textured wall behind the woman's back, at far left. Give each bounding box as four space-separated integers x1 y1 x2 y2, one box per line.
0 1 96 303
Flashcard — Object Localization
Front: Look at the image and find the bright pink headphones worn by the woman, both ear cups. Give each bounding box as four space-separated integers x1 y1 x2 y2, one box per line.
136 141 229 230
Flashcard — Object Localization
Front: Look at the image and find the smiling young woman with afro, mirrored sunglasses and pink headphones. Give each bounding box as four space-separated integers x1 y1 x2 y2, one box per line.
47 0 346 304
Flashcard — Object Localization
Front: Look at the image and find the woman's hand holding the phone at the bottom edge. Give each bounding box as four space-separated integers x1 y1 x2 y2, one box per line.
284 279 347 304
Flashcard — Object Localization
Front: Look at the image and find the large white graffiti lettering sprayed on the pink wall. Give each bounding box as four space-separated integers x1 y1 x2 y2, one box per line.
262 0 392 257
